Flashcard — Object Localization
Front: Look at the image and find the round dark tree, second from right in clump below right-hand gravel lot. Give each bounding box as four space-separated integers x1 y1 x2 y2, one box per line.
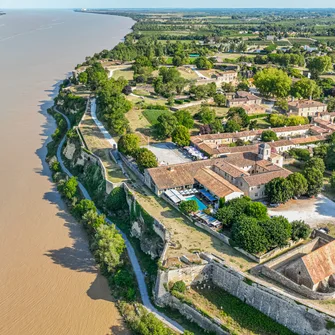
260 216 292 248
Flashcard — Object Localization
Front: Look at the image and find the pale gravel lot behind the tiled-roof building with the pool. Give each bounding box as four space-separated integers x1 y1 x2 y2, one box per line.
144 142 192 165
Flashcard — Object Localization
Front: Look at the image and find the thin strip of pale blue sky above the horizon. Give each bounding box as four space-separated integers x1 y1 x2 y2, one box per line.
0 0 335 8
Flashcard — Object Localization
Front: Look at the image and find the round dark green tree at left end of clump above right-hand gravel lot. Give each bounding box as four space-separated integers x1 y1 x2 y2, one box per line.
265 177 293 204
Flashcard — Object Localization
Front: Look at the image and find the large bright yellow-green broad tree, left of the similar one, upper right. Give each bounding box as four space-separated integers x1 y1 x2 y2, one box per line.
254 67 292 98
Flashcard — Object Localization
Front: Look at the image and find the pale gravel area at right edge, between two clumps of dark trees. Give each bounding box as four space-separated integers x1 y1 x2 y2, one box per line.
269 195 335 227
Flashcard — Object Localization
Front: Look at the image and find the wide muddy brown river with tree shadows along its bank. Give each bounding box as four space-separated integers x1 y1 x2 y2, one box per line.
0 10 133 335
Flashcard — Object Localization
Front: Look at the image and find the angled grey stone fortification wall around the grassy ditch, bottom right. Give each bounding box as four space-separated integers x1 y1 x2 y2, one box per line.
155 261 335 335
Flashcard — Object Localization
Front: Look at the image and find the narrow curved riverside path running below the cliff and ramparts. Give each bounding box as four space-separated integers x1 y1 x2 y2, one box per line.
55 108 184 333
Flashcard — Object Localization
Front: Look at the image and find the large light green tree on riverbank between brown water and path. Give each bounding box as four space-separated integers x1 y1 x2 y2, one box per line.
92 225 126 272
